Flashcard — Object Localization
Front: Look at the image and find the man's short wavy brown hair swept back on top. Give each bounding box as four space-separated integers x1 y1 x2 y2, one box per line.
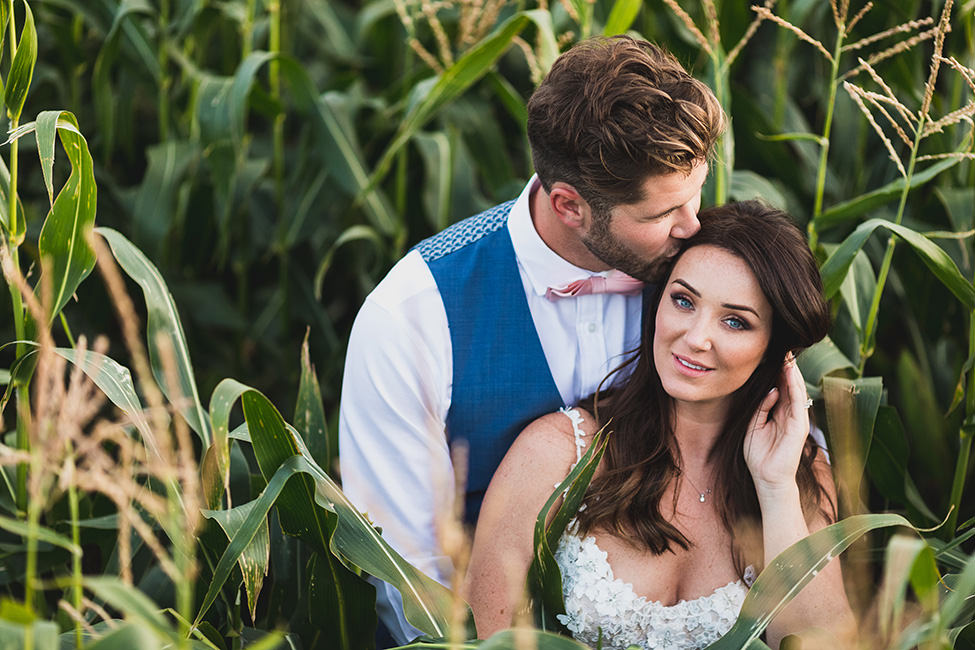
528 36 725 212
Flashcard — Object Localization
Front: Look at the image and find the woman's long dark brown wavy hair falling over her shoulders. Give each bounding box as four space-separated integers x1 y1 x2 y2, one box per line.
577 201 835 574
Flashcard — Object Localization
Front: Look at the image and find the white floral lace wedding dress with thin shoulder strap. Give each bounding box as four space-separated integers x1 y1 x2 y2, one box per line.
555 409 754 650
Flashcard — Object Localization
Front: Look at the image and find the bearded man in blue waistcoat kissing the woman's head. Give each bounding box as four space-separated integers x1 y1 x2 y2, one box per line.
339 37 724 643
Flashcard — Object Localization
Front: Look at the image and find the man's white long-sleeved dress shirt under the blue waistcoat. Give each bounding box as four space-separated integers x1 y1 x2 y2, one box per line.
339 178 642 643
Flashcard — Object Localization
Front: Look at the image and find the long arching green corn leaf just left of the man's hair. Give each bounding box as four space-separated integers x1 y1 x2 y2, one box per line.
368 9 558 188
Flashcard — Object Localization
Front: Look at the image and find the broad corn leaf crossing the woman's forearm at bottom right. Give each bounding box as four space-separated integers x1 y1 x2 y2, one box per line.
708 514 913 650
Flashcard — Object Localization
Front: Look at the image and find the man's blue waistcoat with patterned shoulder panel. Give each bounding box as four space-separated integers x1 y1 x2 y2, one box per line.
416 201 562 524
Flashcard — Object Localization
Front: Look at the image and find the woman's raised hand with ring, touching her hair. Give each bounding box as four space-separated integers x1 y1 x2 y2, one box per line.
744 352 809 499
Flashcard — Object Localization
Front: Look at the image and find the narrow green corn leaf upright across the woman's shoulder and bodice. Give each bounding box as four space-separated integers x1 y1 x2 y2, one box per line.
526 432 607 634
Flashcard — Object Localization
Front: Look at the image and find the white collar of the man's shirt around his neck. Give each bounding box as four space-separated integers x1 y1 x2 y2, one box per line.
508 175 605 296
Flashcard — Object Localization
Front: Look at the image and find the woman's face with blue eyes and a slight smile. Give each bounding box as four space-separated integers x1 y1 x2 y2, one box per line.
653 246 772 405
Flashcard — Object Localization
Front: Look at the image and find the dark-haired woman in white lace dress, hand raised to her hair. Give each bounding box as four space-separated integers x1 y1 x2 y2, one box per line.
465 202 852 649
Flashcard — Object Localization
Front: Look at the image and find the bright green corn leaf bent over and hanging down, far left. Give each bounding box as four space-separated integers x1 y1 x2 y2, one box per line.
23 111 97 320
